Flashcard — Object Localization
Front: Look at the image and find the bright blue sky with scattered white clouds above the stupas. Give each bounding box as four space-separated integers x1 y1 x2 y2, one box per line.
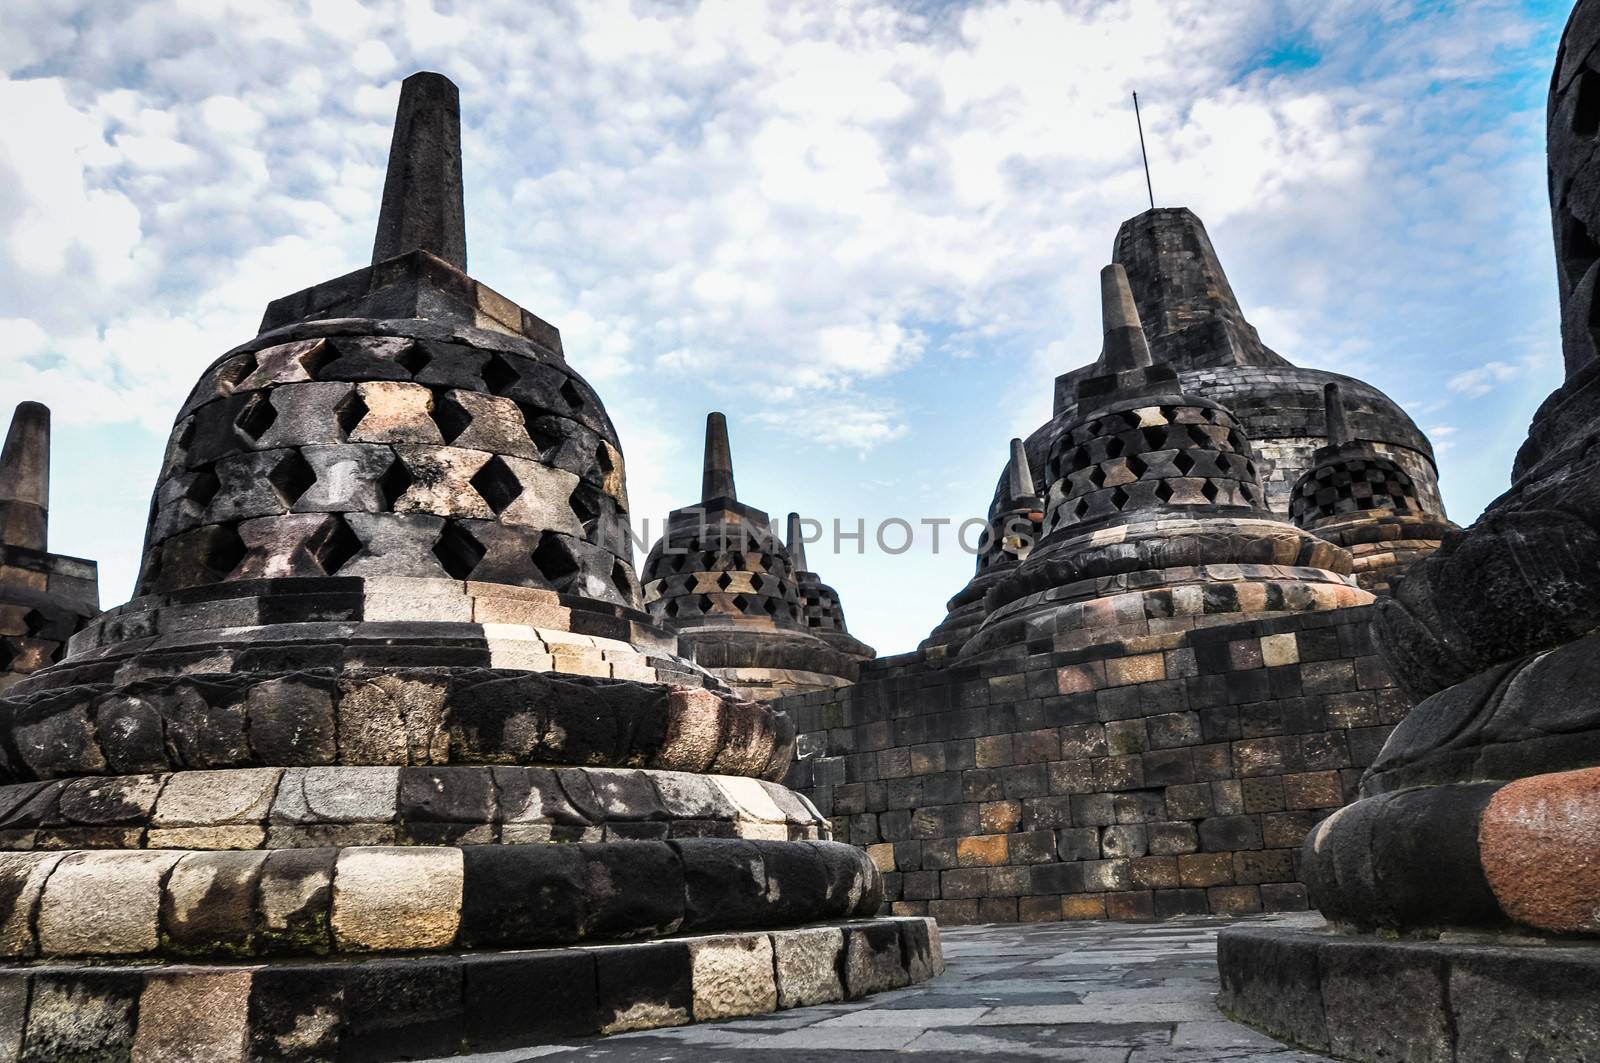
0 0 1571 652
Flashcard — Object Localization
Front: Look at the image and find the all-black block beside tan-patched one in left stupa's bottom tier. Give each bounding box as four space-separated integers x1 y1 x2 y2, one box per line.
466 951 600 1050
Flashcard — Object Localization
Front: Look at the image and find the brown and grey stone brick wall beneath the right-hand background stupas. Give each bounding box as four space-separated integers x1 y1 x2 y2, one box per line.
779 607 1410 924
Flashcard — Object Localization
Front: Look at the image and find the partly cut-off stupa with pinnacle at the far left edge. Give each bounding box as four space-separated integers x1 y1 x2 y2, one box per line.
0 402 99 692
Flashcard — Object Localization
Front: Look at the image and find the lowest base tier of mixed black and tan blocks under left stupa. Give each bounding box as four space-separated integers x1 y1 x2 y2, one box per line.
0 917 944 1063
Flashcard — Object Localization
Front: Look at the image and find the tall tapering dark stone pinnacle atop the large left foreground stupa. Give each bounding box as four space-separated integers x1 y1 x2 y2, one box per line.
373 70 467 272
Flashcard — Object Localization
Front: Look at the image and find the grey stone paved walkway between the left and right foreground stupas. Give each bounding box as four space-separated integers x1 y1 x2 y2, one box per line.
435 916 1325 1063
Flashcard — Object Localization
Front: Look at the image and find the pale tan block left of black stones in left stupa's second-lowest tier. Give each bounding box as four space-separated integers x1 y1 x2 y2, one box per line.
333 847 462 951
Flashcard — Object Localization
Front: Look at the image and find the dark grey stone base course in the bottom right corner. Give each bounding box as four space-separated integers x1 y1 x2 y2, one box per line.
1218 927 1600 1063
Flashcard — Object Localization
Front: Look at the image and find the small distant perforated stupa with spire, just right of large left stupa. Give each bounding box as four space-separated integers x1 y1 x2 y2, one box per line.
643 413 872 700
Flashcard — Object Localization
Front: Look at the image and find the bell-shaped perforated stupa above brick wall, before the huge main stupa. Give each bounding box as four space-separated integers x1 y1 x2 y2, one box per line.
960 264 1371 660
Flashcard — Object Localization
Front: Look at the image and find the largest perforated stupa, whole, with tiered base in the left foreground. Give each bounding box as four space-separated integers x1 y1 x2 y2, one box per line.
0 74 941 1061
